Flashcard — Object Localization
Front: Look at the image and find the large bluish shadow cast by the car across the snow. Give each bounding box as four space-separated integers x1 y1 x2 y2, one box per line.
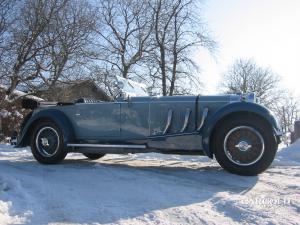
0 156 258 224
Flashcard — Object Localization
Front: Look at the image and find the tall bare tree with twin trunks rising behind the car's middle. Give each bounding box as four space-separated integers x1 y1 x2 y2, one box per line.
150 0 216 95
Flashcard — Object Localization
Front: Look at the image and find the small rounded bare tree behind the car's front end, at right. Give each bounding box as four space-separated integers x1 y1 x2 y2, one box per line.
221 59 280 106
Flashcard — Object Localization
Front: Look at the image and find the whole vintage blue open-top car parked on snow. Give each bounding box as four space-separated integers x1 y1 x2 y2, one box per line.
17 79 281 175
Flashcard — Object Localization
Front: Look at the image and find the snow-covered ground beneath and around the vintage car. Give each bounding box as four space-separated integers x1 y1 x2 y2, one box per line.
0 141 300 225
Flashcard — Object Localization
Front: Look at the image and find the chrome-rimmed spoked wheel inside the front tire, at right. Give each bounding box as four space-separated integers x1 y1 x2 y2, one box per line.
224 126 265 166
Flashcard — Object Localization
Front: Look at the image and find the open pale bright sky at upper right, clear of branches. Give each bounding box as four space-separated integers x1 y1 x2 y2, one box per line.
197 0 300 96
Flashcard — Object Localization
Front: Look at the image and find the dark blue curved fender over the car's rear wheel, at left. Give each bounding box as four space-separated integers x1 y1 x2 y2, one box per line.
16 109 74 148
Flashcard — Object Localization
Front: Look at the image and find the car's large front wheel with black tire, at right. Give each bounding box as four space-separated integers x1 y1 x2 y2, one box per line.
212 114 278 176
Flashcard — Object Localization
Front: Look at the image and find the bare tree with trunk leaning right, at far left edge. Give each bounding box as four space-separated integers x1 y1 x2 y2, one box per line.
5 0 67 99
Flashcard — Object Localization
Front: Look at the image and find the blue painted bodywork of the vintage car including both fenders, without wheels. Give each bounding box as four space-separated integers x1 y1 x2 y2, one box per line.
18 95 280 157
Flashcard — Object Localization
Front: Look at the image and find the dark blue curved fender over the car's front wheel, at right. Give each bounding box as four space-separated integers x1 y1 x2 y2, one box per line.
202 102 281 158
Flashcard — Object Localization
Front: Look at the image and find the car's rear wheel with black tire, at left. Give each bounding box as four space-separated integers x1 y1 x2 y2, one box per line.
30 121 67 164
